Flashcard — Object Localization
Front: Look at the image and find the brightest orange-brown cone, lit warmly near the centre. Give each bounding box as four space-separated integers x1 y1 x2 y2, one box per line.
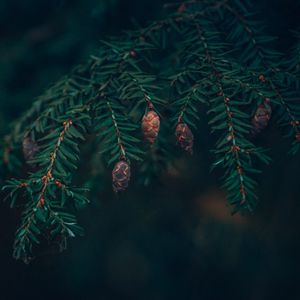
142 109 160 144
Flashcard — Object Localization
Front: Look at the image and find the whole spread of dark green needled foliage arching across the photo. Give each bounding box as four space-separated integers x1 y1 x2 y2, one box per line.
3 0 300 261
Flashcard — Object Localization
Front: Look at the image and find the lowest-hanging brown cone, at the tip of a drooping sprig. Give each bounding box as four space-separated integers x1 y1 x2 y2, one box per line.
112 160 130 193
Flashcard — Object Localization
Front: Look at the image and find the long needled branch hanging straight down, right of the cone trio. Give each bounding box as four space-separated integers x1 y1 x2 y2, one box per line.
195 23 266 211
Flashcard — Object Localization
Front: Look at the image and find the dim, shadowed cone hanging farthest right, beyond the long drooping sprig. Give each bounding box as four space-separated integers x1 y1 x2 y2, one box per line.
251 100 272 136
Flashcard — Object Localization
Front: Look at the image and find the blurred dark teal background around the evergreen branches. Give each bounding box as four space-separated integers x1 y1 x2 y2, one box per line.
0 0 300 300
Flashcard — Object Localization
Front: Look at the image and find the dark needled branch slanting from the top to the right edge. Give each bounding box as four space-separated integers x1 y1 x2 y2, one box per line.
224 0 300 153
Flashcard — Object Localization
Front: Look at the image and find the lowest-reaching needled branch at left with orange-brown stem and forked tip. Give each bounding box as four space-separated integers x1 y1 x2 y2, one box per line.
4 118 86 262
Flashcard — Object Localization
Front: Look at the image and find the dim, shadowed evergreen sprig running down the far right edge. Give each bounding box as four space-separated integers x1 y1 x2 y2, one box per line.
218 1 300 154
